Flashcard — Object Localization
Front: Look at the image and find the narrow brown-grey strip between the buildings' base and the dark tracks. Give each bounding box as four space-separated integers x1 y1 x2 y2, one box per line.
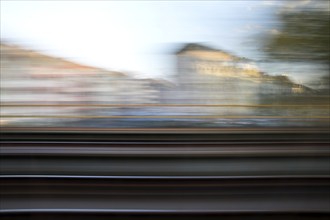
1 126 330 133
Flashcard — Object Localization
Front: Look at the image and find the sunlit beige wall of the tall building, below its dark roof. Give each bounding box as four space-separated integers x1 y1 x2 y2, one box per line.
167 43 260 115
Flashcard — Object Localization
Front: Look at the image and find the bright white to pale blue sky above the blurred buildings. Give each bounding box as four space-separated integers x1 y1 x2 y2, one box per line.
1 0 324 83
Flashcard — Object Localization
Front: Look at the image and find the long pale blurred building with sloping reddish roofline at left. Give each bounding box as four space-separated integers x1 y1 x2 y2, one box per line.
0 43 158 123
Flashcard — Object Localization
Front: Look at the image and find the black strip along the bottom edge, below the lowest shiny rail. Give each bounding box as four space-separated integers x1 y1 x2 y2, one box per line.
1 210 330 220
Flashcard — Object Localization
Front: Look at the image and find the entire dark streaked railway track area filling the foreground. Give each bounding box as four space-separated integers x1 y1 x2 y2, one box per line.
0 131 330 219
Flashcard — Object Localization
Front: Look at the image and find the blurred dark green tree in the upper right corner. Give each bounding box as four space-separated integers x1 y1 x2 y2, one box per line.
263 0 330 68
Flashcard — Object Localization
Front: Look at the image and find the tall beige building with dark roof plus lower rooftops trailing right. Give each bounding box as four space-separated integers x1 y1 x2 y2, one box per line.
164 43 314 115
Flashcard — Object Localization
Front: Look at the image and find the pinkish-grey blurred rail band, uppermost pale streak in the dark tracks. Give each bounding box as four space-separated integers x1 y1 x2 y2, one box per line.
0 140 330 157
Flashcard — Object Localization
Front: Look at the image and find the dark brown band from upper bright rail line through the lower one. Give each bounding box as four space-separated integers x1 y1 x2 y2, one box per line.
0 176 330 216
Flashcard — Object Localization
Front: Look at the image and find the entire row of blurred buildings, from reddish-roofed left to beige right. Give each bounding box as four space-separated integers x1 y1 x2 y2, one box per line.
0 43 312 123
